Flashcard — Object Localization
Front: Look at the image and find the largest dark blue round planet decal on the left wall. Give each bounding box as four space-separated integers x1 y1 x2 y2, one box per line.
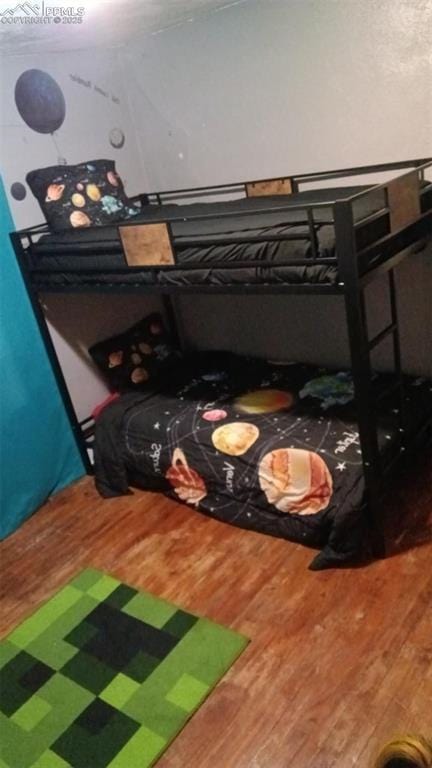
15 69 66 133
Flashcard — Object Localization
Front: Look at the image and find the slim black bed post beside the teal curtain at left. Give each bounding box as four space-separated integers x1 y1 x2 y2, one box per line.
10 232 93 475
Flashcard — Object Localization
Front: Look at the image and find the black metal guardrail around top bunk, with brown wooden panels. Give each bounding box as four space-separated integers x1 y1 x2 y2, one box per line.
13 159 432 292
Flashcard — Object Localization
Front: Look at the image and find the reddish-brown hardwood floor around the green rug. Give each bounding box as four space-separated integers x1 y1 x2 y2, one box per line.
0 459 432 768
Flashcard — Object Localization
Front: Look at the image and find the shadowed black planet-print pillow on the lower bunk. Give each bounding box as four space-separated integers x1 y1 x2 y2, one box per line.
89 312 180 392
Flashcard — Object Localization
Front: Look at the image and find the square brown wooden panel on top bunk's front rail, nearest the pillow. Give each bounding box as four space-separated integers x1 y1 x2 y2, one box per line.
119 223 175 267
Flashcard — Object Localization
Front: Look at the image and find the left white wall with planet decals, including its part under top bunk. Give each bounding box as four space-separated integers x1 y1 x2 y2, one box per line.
0 49 159 418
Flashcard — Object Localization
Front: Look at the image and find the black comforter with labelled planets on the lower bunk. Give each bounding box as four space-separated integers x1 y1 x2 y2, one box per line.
95 353 432 569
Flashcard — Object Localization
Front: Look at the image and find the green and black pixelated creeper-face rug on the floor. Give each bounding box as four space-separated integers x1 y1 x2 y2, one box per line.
0 570 248 768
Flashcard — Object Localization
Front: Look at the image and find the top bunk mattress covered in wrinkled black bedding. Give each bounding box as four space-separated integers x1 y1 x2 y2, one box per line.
31 186 388 286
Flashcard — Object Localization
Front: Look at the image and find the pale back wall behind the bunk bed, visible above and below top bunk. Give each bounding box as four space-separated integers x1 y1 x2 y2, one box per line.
122 0 432 374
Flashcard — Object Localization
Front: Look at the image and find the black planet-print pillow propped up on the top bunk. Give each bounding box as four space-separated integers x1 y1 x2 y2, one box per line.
26 160 139 231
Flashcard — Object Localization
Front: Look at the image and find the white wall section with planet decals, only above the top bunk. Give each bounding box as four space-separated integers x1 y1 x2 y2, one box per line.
0 49 146 228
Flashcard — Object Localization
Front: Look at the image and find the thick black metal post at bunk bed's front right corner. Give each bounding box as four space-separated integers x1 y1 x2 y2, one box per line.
334 200 385 557
